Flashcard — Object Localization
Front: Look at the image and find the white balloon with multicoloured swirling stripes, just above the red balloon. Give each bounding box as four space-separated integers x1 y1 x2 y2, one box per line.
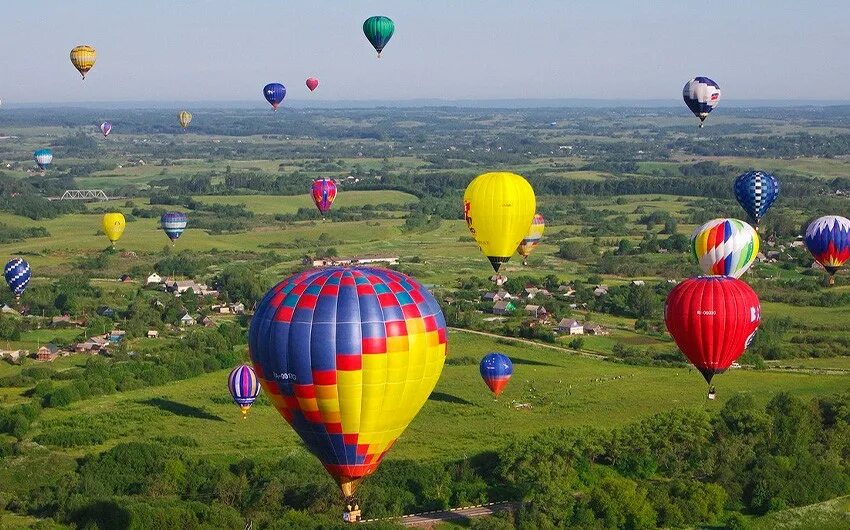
691 219 759 278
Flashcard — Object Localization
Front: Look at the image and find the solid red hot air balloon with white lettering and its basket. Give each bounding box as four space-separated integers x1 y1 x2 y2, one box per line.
664 276 761 397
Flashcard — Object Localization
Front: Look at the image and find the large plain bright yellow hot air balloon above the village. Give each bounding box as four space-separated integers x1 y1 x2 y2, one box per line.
463 172 537 272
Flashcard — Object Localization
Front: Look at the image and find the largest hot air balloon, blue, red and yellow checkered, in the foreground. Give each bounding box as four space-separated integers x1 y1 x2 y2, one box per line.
248 267 446 506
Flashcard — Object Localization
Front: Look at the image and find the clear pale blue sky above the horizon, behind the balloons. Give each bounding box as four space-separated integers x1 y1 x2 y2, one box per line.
0 0 850 103
